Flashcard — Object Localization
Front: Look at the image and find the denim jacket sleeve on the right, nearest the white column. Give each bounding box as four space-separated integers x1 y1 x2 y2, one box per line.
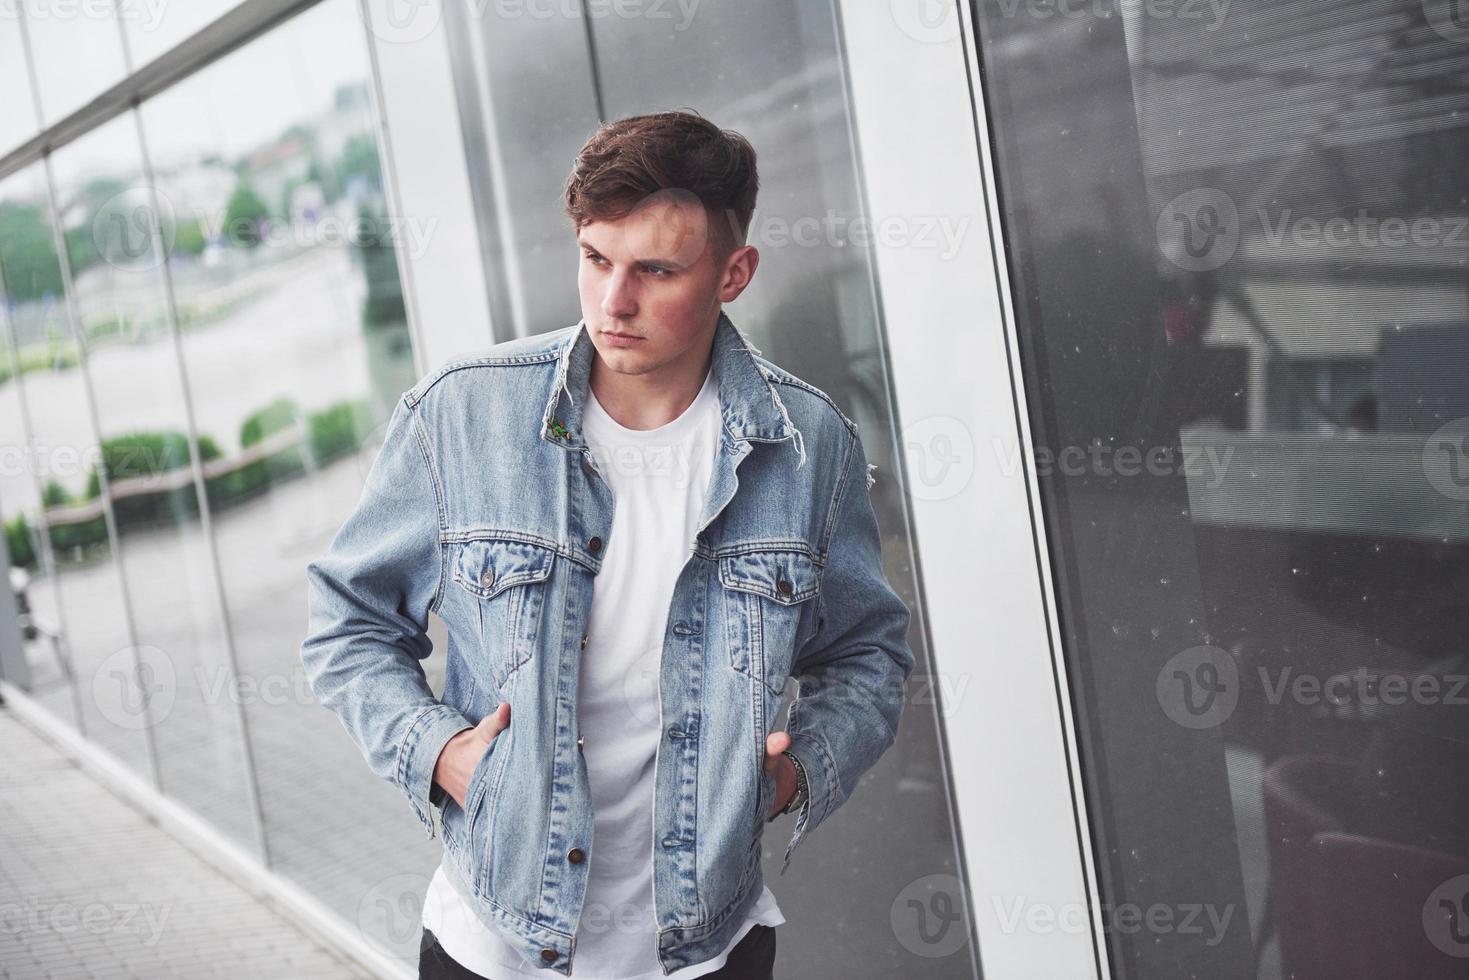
780 432 914 874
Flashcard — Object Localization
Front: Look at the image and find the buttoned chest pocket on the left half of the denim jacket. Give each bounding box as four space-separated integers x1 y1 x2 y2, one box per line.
452 538 555 689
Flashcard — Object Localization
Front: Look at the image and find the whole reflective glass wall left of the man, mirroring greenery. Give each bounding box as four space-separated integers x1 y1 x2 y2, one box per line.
0 0 428 954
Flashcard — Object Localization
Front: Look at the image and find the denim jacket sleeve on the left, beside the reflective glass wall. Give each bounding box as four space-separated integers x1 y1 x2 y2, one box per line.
301 397 474 837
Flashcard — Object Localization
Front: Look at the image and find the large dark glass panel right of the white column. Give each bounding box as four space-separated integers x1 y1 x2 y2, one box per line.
977 0 1469 980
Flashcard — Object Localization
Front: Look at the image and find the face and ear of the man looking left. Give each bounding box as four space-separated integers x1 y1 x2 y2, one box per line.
577 192 758 375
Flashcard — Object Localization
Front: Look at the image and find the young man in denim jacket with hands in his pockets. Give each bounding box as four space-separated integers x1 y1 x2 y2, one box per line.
301 112 914 980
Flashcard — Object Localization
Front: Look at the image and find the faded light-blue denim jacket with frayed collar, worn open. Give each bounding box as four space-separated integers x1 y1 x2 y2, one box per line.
301 313 914 976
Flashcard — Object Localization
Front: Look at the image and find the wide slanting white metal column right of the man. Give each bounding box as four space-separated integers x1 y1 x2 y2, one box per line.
840 0 1111 980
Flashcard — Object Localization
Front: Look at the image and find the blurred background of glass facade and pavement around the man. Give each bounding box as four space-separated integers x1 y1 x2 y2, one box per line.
0 0 1469 980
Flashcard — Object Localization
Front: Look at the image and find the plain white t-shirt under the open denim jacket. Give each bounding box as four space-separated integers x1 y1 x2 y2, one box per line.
423 364 786 980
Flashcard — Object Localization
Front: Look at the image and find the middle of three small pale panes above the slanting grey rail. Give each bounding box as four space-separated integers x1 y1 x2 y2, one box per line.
16 0 129 125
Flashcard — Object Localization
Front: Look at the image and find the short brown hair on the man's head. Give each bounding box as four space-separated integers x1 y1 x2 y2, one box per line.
564 110 759 254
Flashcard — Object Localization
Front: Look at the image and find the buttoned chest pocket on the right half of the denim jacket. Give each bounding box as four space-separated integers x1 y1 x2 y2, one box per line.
720 550 821 695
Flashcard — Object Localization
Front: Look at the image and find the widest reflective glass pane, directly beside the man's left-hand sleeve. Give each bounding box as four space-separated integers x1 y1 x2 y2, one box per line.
141 0 428 945
